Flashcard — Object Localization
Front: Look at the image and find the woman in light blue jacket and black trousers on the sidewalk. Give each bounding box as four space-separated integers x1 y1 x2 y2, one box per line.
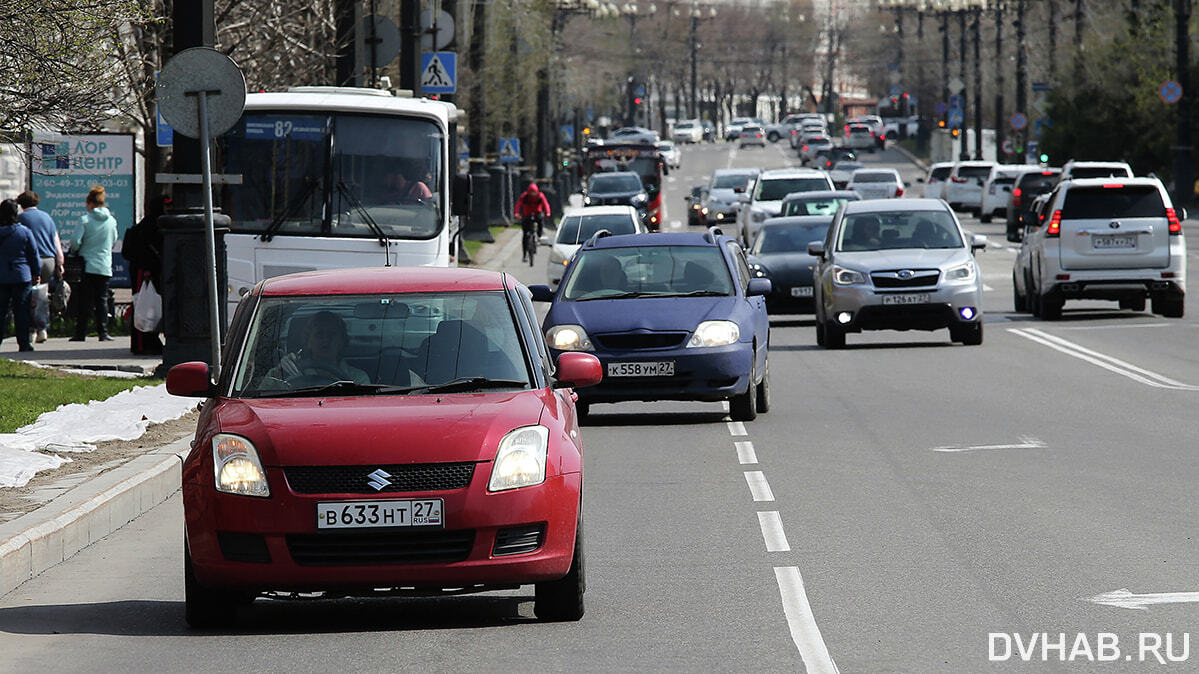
71 185 116 342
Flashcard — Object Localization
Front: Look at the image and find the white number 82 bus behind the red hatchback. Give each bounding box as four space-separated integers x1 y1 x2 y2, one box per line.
213 86 469 317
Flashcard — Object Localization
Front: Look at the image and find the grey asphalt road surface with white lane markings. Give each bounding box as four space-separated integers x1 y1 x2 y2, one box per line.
0 139 1199 673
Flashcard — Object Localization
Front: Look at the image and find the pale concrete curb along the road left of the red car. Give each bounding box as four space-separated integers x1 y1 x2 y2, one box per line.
0 437 192 596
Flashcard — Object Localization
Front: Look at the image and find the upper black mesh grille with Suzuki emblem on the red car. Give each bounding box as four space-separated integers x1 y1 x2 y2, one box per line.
283 462 475 494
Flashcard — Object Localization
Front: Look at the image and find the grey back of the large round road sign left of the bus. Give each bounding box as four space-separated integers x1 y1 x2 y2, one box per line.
155 47 246 138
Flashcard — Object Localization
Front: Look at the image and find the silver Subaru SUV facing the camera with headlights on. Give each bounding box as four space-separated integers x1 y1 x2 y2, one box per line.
808 199 987 349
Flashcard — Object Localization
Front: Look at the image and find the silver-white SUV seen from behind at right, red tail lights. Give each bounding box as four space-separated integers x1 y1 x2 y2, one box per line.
1012 177 1187 320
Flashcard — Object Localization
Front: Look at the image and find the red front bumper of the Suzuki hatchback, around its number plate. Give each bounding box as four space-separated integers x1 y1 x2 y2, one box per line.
183 463 582 591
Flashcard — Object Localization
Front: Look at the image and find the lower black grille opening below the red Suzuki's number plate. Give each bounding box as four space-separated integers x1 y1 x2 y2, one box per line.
287 529 475 566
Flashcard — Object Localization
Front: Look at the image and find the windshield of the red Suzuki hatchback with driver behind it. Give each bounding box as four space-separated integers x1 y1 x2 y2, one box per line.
233 291 530 397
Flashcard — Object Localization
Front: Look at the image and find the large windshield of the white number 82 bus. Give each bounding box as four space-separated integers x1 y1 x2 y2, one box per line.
215 110 445 239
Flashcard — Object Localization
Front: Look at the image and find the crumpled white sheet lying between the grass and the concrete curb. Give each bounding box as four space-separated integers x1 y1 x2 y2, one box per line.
0 384 195 488
